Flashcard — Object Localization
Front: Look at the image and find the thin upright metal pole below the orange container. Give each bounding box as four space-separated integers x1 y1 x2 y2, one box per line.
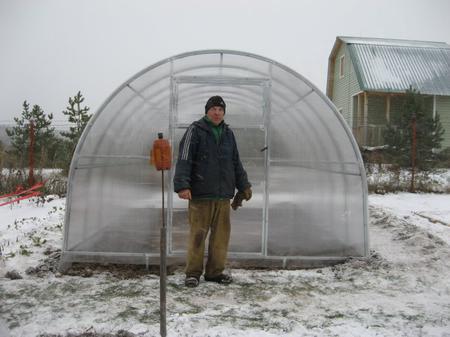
159 170 167 337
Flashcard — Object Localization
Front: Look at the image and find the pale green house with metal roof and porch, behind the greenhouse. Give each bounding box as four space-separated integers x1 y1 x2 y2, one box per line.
327 36 450 148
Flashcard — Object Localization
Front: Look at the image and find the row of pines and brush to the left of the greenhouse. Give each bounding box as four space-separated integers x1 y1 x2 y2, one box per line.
0 91 92 174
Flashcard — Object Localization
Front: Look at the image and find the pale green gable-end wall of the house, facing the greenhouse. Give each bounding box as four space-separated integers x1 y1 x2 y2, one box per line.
331 44 360 127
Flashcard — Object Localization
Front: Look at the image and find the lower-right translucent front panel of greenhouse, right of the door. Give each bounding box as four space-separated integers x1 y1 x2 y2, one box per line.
268 164 364 257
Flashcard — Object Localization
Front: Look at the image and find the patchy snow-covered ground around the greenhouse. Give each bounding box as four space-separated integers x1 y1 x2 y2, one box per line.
0 193 450 337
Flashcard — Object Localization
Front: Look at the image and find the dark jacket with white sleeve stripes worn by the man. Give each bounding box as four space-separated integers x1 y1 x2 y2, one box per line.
174 118 251 199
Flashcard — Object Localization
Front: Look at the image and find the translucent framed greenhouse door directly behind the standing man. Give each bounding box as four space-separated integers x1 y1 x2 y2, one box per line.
168 77 270 256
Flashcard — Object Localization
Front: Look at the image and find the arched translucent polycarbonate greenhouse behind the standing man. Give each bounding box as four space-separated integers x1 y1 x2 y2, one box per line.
61 50 368 268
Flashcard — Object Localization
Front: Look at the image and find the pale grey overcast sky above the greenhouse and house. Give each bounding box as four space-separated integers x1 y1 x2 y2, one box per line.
0 0 450 123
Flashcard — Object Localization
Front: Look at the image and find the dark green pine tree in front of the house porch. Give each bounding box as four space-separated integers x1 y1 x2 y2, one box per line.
384 87 444 170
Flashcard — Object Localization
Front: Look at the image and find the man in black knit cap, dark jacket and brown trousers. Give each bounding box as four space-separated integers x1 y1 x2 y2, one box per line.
174 96 252 287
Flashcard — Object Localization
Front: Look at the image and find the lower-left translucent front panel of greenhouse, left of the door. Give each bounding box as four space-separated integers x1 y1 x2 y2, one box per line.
68 158 163 253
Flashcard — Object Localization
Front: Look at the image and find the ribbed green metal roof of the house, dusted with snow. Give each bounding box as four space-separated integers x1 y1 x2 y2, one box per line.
338 37 450 96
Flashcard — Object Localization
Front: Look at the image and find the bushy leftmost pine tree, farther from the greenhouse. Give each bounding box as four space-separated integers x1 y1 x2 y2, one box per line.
6 101 55 167
